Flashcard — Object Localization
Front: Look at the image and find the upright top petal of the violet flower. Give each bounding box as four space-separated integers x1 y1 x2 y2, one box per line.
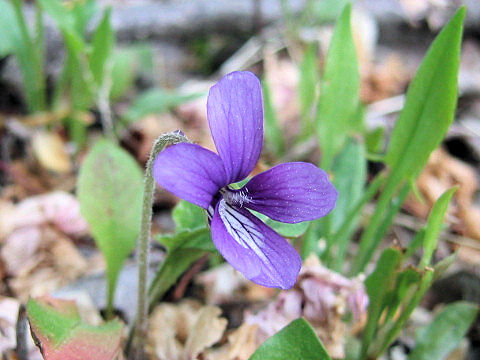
207 71 263 183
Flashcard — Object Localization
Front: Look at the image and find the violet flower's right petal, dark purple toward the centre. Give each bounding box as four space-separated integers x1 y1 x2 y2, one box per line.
240 162 338 223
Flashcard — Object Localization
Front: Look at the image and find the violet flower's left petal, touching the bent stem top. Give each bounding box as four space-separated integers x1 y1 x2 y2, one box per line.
153 143 228 209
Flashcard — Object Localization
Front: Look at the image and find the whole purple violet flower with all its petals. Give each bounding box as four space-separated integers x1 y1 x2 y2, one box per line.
153 72 337 289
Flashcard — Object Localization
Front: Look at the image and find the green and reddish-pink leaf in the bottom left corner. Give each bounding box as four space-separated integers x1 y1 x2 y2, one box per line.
27 297 123 360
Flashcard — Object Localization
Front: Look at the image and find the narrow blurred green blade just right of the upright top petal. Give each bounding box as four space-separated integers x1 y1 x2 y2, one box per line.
262 79 285 156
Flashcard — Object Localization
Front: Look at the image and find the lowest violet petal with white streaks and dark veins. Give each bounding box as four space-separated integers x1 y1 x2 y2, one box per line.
211 199 301 289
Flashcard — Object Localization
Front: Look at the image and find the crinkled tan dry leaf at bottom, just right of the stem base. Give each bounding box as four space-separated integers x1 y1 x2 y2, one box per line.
147 300 227 360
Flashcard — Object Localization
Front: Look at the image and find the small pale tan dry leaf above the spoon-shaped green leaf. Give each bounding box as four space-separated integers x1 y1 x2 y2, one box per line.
32 131 72 173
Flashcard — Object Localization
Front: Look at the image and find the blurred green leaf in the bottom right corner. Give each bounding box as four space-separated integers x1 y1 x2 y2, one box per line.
408 301 478 360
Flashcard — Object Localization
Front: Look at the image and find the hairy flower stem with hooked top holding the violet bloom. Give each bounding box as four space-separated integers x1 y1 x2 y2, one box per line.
130 131 188 360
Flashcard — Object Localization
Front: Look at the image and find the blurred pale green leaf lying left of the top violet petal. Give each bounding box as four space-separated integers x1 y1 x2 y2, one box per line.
125 89 203 122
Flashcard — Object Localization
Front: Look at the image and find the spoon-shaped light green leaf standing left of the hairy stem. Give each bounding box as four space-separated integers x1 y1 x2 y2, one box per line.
77 140 143 312
